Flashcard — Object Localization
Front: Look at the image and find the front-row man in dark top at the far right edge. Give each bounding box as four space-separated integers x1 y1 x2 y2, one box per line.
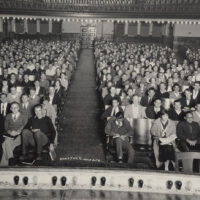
176 112 200 152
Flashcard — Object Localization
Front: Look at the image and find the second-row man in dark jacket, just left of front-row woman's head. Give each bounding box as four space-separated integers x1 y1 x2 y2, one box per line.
145 99 162 119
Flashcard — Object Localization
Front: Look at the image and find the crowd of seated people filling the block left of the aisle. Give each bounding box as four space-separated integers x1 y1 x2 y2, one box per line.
0 40 80 166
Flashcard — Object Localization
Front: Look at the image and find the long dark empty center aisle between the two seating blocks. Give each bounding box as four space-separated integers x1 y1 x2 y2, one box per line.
57 49 105 162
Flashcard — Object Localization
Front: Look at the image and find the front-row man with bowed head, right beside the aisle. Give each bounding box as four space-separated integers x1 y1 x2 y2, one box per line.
105 112 135 164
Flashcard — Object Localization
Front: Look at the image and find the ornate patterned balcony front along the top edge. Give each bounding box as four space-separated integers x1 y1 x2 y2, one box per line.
0 0 200 13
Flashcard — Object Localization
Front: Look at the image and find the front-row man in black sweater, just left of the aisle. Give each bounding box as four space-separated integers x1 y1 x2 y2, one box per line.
20 105 56 161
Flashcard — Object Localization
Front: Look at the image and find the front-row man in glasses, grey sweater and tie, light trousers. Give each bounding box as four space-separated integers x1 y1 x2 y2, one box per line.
0 102 27 166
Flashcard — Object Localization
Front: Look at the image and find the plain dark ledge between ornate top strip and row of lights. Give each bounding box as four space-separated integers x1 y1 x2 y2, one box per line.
0 7 200 19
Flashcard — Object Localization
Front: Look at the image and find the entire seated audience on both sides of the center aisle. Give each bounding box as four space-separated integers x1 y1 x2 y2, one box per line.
0 36 200 171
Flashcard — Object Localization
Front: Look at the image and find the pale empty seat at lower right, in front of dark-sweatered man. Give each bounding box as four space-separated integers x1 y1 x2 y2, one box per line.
175 152 200 172
